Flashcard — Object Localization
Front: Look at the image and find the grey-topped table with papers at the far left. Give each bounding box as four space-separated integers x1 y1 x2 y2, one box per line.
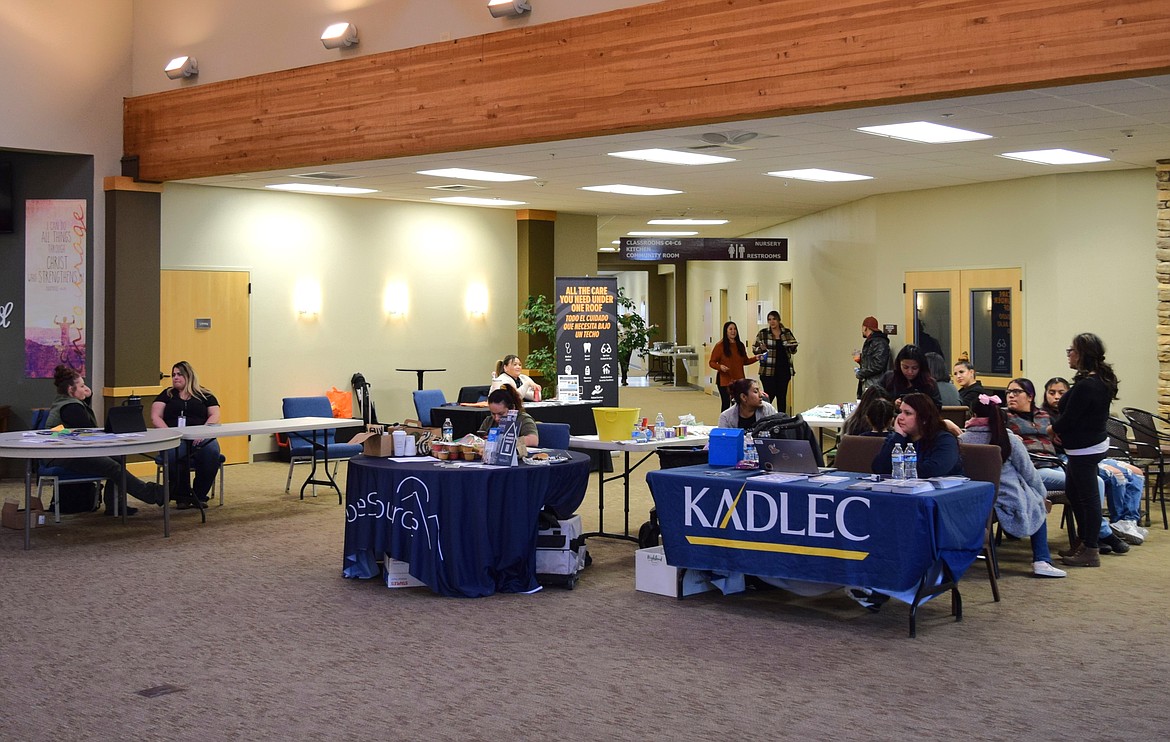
0 428 180 549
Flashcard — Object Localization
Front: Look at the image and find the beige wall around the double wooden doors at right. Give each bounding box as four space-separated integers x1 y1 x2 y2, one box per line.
688 170 1157 410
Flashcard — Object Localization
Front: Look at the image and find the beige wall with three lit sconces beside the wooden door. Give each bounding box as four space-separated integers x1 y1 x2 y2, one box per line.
163 184 516 452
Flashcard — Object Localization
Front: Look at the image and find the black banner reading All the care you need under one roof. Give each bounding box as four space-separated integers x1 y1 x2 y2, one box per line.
557 276 620 407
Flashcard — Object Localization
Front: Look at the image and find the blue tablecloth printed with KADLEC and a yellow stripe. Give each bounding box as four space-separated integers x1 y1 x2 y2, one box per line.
646 466 995 597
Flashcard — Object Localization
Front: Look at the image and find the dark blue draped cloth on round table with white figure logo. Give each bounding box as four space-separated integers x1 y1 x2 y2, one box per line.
343 453 589 598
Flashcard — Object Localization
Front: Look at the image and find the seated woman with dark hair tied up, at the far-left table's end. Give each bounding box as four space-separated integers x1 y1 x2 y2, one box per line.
46 365 163 515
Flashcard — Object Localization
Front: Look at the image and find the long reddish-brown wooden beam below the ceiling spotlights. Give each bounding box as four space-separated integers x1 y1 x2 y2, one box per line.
123 0 1170 181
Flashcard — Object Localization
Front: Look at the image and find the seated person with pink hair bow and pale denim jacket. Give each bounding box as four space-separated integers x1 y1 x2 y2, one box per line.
959 394 1067 577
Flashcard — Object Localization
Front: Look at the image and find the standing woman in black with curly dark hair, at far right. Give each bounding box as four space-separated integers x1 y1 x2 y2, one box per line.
1052 332 1117 566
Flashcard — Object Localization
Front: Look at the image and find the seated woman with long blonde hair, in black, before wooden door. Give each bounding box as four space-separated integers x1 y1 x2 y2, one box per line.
150 360 220 509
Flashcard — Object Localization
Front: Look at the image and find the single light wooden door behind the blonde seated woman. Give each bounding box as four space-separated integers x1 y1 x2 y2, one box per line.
159 270 250 463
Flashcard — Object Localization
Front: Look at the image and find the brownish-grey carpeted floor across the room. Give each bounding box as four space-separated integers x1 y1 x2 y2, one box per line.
0 379 1170 740
